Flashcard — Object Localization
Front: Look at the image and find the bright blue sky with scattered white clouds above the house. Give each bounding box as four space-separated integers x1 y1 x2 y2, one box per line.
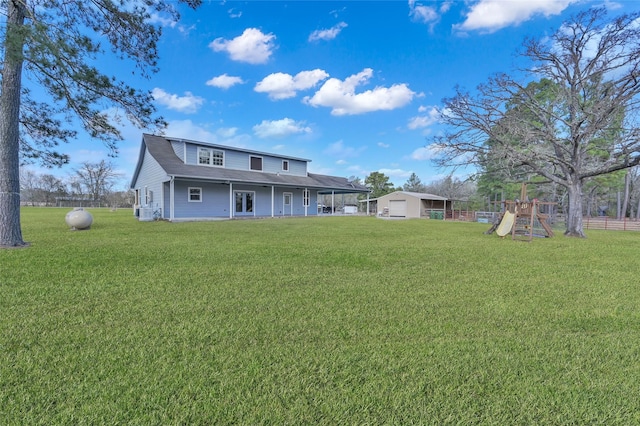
23 0 640 189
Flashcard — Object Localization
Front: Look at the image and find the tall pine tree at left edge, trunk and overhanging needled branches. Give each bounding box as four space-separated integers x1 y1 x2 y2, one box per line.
0 0 201 247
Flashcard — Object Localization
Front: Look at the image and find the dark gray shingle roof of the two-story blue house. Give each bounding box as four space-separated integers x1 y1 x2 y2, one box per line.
132 134 369 193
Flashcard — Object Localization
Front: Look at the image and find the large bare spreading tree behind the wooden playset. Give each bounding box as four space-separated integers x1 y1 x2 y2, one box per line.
433 8 640 237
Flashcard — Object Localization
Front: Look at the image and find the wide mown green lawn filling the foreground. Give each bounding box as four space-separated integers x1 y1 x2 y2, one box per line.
0 208 640 425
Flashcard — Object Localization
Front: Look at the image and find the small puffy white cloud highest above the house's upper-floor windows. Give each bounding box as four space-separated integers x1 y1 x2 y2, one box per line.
209 28 276 64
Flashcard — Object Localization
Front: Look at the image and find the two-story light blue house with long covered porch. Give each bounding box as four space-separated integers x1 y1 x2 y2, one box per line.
131 134 369 221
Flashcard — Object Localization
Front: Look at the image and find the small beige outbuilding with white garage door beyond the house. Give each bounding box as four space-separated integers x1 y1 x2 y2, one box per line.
370 191 447 219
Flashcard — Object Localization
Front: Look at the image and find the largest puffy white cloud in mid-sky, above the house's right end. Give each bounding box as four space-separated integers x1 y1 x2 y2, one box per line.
303 68 416 115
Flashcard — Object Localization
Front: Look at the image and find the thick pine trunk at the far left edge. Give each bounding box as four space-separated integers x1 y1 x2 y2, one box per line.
0 1 27 247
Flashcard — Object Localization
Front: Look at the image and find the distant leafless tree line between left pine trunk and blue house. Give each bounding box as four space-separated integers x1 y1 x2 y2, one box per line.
20 160 134 208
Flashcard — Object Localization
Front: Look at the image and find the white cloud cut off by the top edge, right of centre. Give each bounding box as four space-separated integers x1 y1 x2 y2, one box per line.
454 0 578 33
